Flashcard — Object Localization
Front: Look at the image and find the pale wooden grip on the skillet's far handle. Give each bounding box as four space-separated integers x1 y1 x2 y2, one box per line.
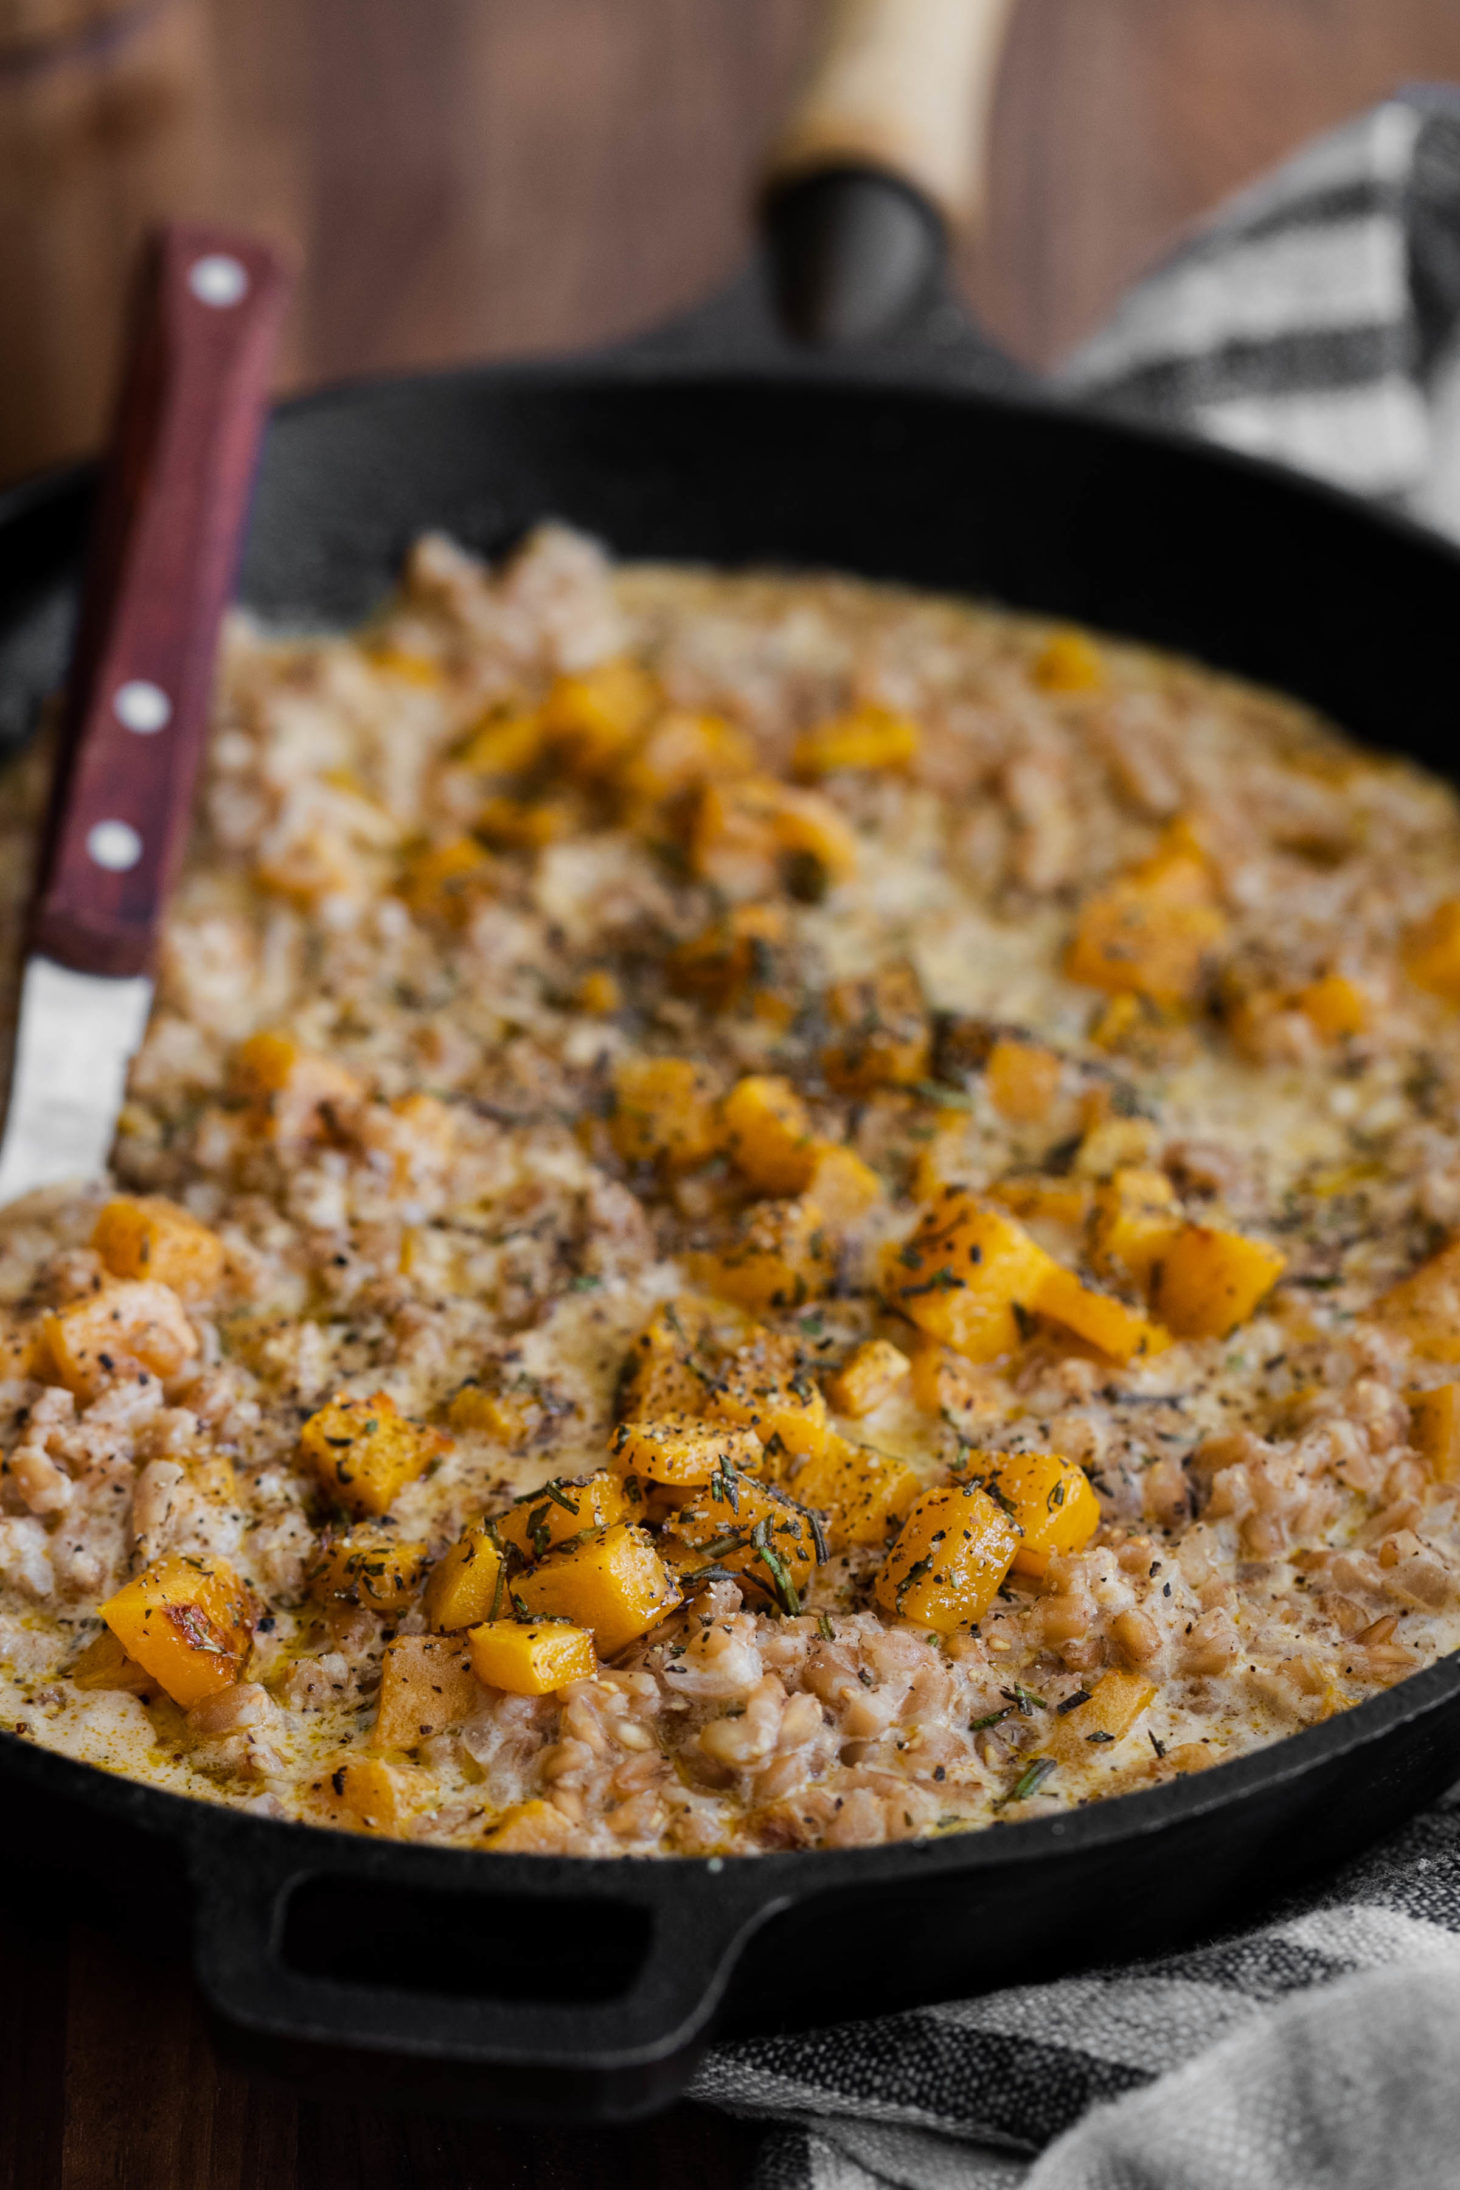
766 0 1013 223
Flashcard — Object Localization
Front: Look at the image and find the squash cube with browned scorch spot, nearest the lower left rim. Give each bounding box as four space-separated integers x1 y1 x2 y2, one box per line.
101 1553 254 1710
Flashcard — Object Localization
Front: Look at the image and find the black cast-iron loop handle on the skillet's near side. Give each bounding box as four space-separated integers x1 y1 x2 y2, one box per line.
193 1826 788 2085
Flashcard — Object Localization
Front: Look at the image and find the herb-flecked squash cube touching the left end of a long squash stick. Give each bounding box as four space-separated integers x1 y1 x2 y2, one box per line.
884 1189 1057 1362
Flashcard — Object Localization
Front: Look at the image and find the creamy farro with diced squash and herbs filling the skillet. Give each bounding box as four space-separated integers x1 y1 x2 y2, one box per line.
0 526 1460 1855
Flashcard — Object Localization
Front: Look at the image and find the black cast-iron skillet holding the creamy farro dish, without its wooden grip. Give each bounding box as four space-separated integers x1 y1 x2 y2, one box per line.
0 59 1460 2118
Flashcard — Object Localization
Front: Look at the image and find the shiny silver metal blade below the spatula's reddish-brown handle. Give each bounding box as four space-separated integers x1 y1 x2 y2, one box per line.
0 957 151 1207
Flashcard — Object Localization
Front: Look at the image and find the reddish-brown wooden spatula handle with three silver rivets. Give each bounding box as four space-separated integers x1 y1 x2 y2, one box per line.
31 226 289 975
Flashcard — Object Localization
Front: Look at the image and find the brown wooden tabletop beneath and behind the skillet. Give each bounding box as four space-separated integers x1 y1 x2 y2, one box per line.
0 0 1460 2190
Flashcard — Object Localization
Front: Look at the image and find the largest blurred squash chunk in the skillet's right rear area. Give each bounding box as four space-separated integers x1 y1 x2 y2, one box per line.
1064 852 1228 1010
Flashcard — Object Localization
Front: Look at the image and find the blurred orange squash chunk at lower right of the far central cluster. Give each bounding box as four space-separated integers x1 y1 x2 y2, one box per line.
690 775 856 898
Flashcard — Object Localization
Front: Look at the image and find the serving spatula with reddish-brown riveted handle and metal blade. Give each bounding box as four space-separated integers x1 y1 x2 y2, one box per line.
0 223 289 1205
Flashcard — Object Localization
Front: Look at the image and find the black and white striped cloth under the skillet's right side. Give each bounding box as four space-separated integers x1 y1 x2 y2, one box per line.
694 90 1460 2190
